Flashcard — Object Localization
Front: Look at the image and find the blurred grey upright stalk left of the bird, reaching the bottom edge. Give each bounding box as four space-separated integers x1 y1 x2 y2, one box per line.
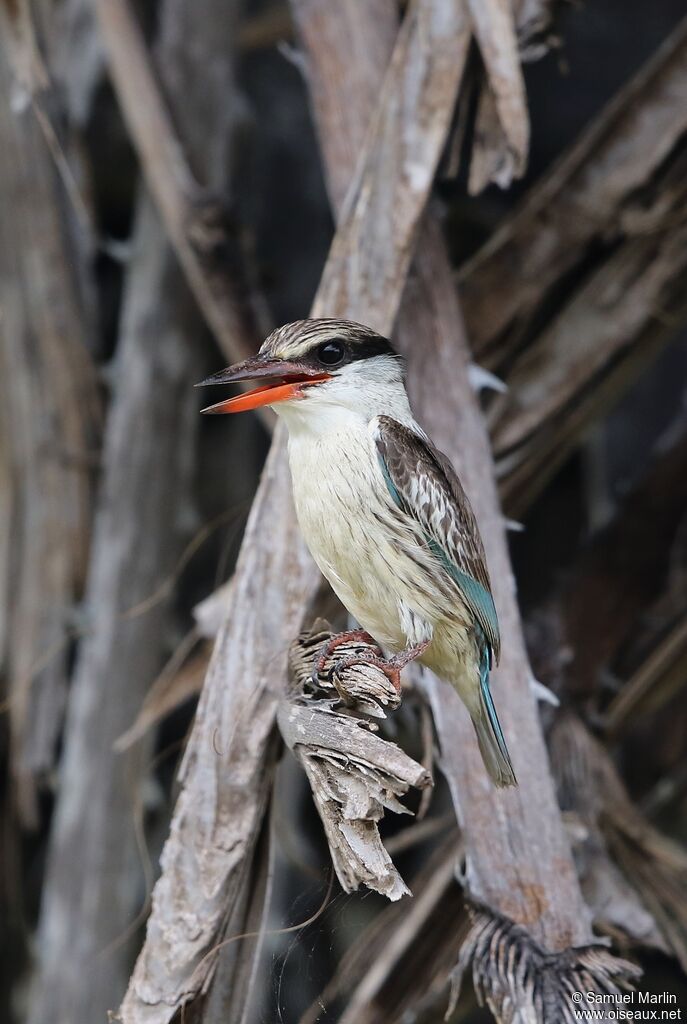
30 195 202 1024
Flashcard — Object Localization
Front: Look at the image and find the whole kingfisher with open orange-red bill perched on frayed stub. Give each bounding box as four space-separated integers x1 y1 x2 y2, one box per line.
201 317 517 787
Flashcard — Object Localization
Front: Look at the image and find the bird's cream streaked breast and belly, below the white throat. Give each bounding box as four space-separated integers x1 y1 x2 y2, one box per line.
289 421 473 649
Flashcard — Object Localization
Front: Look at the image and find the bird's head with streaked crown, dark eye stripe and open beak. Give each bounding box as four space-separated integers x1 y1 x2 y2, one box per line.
196 319 407 421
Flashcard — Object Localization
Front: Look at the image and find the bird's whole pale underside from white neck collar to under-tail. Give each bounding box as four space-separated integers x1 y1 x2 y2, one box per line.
275 361 480 712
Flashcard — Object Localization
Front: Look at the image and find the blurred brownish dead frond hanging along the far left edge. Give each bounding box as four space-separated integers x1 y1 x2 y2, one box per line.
0 25 99 824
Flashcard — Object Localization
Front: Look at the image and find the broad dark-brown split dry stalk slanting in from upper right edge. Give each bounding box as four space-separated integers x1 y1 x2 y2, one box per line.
458 14 687 515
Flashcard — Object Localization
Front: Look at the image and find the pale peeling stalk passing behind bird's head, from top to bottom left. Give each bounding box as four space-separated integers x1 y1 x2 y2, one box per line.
121 0 473 1024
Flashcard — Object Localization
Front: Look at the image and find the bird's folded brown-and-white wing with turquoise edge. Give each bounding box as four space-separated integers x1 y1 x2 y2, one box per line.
374 416 501 660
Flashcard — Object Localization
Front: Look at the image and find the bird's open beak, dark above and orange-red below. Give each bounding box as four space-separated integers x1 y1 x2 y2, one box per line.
196 355 332 415
